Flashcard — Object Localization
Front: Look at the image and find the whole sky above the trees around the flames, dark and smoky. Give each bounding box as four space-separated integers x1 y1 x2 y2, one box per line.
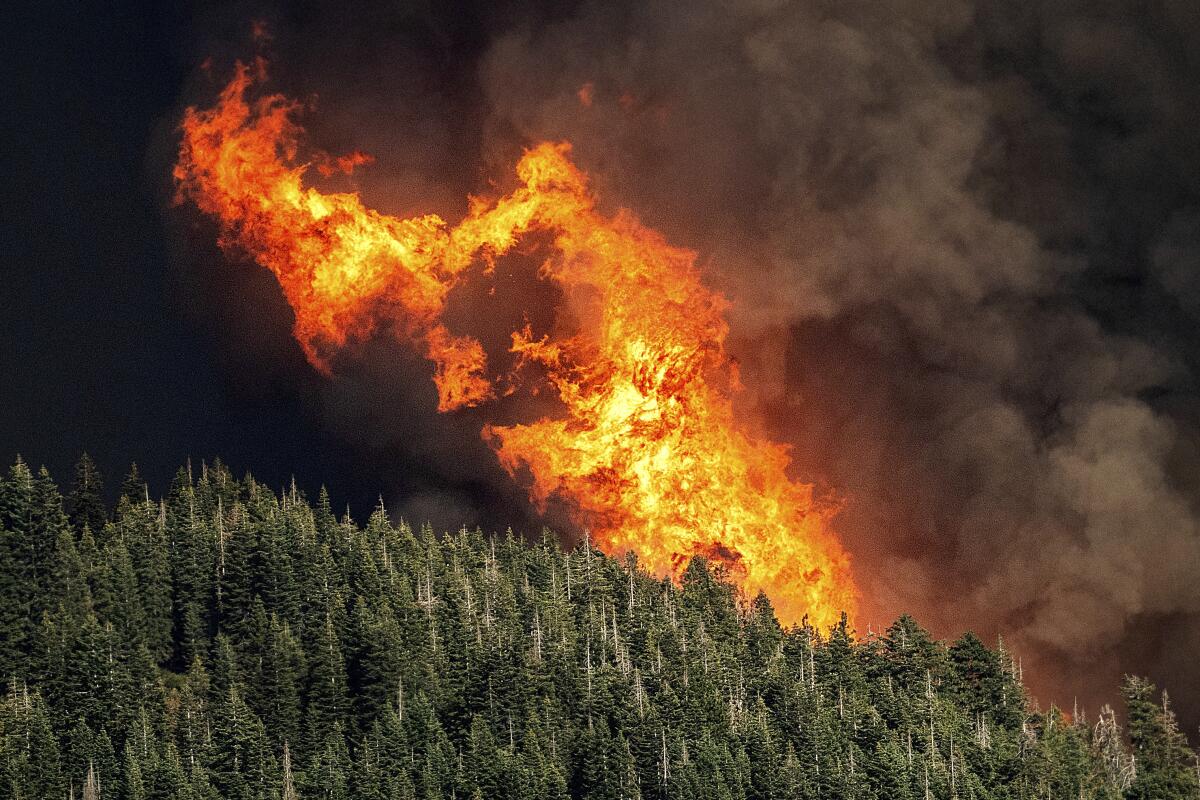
0 0 1200 732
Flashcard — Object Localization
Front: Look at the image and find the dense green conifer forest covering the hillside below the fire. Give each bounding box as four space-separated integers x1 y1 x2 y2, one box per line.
0 456 1200 800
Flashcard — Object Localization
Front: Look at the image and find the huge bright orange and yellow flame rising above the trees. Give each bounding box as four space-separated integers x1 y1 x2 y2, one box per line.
174 62 858 626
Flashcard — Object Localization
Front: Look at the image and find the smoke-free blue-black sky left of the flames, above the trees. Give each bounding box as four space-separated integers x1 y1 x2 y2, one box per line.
0 2 328 501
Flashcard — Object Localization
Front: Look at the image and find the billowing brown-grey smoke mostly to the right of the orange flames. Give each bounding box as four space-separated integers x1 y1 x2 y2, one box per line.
169 0 1200 730
